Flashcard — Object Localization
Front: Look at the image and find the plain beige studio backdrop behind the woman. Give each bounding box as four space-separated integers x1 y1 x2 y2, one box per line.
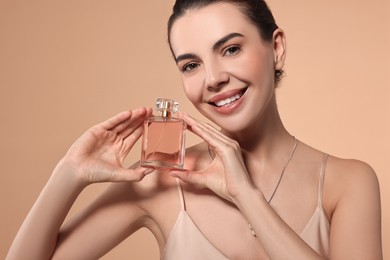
0 0 390 259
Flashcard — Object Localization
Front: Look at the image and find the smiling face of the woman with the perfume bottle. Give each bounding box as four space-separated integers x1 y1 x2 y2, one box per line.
170 3 284 132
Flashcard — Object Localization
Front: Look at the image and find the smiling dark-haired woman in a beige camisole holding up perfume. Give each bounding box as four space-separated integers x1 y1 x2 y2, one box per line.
7 0 382 259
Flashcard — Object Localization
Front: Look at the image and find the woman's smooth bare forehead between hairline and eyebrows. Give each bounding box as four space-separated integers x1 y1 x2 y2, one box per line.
170 3 258 54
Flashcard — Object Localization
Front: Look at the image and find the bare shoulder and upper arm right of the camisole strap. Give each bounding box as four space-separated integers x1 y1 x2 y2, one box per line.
316 156 382 259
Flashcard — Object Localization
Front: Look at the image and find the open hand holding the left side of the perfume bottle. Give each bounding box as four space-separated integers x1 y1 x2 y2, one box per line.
56 108 153 186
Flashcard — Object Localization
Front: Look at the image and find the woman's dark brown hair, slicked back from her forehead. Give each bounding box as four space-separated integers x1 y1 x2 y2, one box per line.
168 0 284 85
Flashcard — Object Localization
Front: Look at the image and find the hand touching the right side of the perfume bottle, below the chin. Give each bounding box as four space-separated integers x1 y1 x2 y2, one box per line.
171 114 253 202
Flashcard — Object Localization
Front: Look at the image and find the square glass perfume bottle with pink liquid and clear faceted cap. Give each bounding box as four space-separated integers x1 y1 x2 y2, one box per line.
141 98 187 169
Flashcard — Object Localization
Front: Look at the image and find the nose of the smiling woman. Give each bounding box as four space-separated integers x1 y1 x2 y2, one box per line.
205 61 229 92
